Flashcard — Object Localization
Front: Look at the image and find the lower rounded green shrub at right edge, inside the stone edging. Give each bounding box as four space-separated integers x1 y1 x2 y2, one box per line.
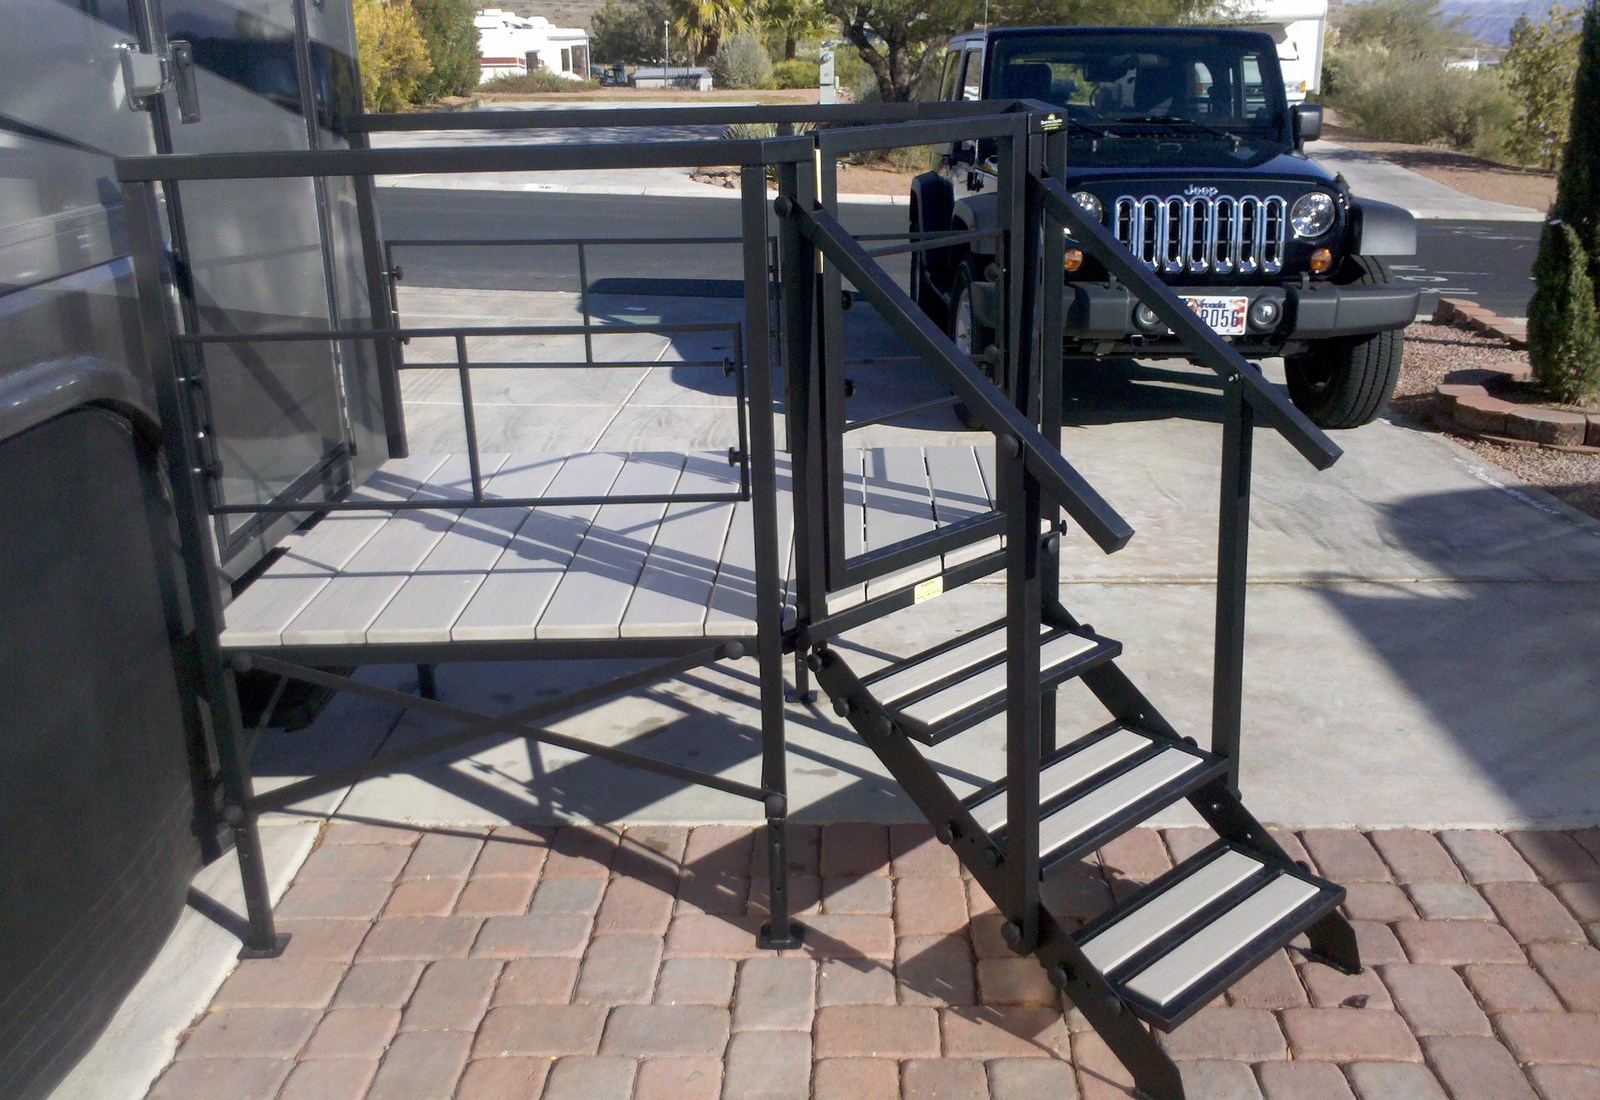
1528 219 1600 401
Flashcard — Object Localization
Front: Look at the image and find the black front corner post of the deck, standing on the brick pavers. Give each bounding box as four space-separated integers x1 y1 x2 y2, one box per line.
739 166 803 948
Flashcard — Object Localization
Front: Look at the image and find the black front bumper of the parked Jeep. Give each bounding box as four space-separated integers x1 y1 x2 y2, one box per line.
1066 283 1421 347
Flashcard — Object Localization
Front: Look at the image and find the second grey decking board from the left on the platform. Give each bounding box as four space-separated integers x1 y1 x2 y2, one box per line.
283 454 506 646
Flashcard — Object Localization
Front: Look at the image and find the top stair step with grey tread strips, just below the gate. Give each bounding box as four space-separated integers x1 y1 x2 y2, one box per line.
864 622 1122 745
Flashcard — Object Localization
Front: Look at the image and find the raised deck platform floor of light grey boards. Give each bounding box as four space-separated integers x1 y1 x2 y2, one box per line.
221 446 998 651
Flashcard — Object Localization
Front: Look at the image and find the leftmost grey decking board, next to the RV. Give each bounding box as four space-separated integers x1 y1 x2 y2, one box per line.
212 454 448 648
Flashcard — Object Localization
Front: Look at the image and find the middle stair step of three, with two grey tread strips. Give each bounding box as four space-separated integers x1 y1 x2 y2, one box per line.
966 723 1227 867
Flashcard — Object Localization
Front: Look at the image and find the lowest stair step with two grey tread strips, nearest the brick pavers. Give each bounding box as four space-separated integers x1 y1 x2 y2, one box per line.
1072 841 1344 1031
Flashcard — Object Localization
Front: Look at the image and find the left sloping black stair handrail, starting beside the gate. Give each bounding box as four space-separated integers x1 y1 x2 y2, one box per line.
793 200 1133 553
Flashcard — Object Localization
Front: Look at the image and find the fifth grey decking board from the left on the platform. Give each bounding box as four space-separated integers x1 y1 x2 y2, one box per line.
533 451 686 638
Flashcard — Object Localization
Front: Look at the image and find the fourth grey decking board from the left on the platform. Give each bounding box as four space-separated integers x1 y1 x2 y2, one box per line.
450 451 627 641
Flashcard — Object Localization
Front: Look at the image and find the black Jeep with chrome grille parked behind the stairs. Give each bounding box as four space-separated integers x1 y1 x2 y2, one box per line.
910 27 1418 428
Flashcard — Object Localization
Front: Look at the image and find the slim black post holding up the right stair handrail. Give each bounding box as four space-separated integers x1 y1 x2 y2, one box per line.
1211 374 1256 795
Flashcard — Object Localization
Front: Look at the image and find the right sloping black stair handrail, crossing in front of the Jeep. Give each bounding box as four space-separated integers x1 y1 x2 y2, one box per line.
1029 174 1344 470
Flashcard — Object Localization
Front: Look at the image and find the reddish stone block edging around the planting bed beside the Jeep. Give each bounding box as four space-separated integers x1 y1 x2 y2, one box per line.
1434 297 1600 454
